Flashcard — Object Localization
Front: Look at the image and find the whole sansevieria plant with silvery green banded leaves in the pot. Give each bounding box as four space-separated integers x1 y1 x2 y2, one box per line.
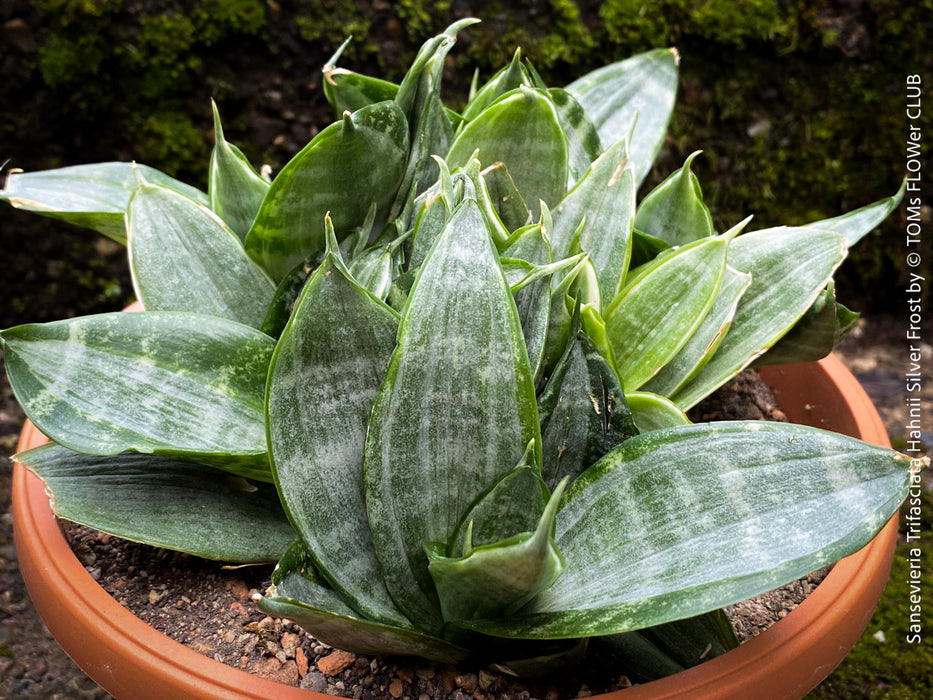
0 20 910 677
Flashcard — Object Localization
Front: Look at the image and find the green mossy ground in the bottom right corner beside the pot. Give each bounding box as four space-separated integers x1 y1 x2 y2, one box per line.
807 484 933 700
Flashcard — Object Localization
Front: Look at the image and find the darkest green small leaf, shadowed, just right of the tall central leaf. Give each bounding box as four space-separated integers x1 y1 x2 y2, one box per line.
538 333 638 488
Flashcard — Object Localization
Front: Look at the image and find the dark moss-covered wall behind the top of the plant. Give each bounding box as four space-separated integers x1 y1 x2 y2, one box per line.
0 0 933 311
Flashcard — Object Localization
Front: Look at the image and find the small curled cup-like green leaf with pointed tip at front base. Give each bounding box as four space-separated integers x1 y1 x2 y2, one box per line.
425 481 566 622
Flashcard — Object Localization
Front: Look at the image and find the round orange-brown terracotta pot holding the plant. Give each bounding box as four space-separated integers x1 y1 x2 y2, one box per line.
13 357 897 700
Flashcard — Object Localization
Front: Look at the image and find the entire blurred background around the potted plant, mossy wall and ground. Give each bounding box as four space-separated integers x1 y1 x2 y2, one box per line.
0 0 933 700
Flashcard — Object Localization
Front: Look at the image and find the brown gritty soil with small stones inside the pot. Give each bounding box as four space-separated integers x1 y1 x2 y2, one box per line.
51 372 825 700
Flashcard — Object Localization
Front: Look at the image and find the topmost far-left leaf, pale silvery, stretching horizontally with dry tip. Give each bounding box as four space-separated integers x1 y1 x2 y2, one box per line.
0 163 208 243
